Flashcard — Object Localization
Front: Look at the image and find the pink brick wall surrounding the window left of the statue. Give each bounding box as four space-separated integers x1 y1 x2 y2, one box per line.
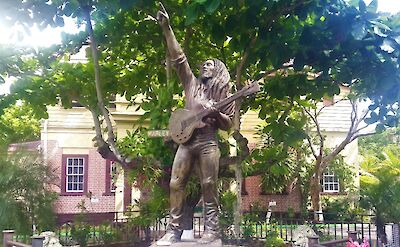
47 141 115 214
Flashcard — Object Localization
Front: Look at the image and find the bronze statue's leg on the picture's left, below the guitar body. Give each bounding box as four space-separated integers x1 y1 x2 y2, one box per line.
169 145 192 230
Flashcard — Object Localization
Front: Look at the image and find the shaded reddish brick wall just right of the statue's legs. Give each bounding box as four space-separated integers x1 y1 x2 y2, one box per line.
242 176 301 212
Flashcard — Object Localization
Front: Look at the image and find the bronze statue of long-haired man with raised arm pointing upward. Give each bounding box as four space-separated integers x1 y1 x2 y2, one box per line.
157 4 234 245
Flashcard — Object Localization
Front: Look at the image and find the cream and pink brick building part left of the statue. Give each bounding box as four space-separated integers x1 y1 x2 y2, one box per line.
41 107 131 224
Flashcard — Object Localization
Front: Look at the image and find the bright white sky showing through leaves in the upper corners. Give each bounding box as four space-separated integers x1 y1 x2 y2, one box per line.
0 0 400 94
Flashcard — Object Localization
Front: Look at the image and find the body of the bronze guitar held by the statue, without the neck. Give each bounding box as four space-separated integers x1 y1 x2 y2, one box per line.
168 109 205 144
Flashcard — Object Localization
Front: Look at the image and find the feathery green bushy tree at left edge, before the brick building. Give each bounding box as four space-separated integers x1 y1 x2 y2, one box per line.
0 150 56 235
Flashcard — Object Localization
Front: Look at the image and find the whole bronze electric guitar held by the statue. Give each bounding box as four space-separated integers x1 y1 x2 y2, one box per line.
168 81 260 144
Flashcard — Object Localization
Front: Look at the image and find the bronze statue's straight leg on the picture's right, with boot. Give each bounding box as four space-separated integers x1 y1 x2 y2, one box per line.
199 145 220 243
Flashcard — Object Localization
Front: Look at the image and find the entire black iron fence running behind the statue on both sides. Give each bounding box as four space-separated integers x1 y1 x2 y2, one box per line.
9 211 398 246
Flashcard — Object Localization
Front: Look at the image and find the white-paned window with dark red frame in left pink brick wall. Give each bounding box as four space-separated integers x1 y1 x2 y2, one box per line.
61 155 88 195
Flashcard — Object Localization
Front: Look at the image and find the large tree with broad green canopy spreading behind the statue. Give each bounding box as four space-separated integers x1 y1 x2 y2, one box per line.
0 0 400 230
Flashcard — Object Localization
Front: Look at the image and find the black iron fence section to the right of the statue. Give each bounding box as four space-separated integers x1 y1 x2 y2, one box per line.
238 212 398 247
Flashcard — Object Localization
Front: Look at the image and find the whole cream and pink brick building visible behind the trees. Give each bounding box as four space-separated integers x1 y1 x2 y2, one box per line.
37 88 358 224
